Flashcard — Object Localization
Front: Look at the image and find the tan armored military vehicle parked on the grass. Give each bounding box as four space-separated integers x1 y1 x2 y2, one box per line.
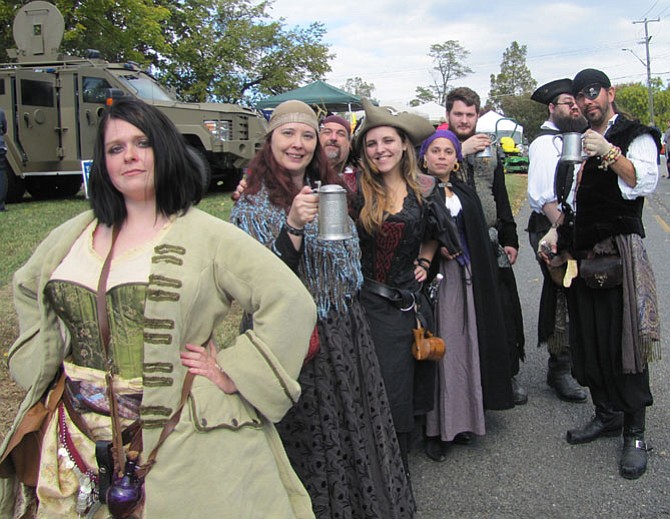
0 0 265 201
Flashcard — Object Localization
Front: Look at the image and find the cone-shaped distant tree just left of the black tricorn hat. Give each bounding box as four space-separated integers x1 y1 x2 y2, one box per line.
487 41 537 111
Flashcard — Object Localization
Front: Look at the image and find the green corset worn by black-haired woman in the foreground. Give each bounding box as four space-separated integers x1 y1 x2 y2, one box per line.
44 280 146 379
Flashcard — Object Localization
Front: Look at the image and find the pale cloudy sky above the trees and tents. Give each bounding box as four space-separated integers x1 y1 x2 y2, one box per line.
270 0 670 104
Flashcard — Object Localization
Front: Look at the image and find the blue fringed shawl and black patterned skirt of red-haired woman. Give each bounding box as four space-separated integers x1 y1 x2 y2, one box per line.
231 191 415 519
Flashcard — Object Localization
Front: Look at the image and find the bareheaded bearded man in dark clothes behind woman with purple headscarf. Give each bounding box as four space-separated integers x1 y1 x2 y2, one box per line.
446 87 528 405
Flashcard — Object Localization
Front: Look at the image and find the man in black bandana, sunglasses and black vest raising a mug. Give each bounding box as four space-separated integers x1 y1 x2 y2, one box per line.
540 69 660 479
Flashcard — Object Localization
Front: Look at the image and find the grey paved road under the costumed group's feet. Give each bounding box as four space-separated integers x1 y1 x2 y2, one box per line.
410 167 670 519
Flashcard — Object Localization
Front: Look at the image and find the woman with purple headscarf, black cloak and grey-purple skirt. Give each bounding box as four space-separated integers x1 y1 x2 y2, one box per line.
419 130 520 461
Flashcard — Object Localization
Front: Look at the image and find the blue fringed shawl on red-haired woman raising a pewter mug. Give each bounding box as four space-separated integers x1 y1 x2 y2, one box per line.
230 187 363 319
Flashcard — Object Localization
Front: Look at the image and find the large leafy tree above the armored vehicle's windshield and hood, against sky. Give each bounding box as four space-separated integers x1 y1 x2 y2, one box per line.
162 0 333 104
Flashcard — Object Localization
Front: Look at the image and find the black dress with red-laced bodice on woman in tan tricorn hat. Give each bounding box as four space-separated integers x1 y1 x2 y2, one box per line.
358 175 457 443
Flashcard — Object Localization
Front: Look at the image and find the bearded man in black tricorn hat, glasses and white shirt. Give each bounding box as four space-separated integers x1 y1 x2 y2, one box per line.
528 79 587 402
